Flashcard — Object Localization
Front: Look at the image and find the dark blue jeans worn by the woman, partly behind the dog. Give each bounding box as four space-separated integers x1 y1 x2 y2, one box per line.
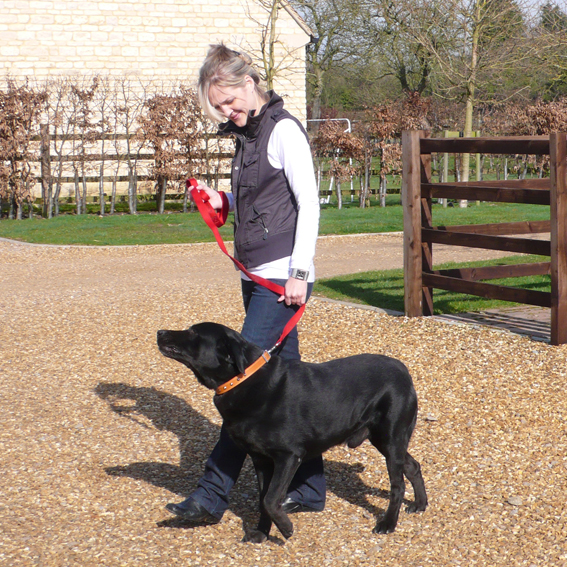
186 280 326 519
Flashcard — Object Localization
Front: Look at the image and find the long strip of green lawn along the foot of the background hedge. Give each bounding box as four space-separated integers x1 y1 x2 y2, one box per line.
0 195 550 246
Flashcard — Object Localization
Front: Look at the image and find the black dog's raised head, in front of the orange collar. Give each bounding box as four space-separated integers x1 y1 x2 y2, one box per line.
157 323 262 390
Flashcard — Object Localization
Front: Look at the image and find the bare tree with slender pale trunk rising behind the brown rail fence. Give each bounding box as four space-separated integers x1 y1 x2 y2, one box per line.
380 0 540 201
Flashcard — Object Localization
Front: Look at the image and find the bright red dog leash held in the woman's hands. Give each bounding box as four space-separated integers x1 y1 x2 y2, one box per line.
186 178 306 353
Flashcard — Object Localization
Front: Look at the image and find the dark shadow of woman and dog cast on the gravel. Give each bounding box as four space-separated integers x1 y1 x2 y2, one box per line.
94 382 389 528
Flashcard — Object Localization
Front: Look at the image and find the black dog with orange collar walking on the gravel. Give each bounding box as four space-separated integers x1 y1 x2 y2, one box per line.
157 323 427 543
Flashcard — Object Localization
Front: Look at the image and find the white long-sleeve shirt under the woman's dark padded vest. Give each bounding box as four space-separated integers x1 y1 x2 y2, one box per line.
228 118 319 282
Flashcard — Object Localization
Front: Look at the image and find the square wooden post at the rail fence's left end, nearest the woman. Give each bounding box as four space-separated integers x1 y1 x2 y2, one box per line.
402 130 423 317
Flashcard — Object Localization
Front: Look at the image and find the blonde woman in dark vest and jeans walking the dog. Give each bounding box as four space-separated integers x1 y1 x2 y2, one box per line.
166 44 325 523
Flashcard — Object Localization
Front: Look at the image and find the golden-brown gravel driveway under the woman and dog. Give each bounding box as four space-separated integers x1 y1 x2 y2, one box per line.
0 235 567 567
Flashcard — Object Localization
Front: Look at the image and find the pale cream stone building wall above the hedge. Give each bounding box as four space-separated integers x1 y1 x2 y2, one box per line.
0 0 310 120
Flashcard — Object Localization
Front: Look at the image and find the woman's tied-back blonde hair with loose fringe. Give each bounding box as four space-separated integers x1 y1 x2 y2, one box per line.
197 43 266 122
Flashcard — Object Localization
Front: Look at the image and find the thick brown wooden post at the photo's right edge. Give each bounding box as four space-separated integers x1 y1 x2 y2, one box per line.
549 132 567 345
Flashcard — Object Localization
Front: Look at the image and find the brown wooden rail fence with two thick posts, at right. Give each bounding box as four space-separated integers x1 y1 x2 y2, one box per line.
402 131 567 345
